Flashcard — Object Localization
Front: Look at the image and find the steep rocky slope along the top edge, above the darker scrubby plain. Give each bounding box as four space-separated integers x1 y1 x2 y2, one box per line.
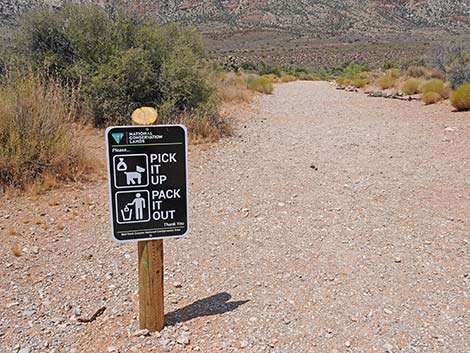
0 0 470 38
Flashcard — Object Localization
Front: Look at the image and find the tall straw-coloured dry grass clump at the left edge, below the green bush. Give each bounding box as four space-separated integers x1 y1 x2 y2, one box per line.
0 75 94 190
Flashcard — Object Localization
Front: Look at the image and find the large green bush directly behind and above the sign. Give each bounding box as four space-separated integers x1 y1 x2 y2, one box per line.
10 3 218 125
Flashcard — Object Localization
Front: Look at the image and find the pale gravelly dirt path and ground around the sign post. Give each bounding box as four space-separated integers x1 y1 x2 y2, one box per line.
0 82 470 353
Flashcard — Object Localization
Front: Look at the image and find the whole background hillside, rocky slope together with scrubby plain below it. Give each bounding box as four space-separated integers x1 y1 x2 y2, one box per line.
0 0 470 68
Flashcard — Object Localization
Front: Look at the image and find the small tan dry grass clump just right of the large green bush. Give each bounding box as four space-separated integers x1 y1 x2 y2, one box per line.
216 73 253 103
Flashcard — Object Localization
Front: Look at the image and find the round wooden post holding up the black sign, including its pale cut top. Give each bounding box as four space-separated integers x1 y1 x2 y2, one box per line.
132 107 165 332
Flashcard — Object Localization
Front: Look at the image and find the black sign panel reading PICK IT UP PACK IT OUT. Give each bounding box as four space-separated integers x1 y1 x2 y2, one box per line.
106 125 188 241
